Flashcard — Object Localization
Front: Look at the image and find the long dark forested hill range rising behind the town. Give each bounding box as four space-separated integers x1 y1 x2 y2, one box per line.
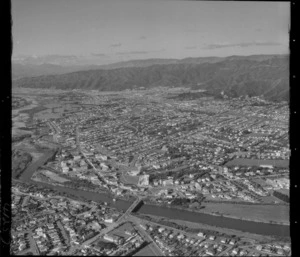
13 55 289 101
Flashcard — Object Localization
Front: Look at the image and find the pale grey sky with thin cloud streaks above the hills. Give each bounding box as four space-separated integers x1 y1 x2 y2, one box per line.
12 0 290 64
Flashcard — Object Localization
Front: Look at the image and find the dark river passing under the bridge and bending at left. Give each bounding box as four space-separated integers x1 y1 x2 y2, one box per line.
20 153 290 237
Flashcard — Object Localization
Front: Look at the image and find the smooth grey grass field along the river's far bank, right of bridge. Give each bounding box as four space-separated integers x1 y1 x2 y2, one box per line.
203 203 289 223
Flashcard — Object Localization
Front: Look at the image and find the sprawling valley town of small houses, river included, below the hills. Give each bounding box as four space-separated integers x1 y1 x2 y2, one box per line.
11 87 291 256
